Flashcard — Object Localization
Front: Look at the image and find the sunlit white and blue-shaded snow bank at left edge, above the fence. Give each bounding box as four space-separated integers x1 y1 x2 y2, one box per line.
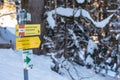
0 10 17 45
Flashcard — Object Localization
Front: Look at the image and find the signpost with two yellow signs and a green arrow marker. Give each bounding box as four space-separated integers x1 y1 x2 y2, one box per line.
16 6 41 80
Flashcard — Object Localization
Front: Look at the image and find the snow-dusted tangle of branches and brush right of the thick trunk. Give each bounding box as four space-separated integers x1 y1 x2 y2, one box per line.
45 0 120 79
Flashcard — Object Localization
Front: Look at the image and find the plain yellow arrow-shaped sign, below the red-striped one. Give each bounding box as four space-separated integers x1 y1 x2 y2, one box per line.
16 37 41 50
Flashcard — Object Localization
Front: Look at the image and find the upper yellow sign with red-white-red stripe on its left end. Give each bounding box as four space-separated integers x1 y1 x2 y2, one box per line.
16 24 41 36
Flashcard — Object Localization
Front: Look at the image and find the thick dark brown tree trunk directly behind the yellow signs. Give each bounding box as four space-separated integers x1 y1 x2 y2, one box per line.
21 0 45 54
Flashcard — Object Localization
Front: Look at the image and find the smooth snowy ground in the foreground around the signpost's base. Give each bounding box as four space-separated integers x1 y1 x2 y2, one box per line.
0 49 115 80
